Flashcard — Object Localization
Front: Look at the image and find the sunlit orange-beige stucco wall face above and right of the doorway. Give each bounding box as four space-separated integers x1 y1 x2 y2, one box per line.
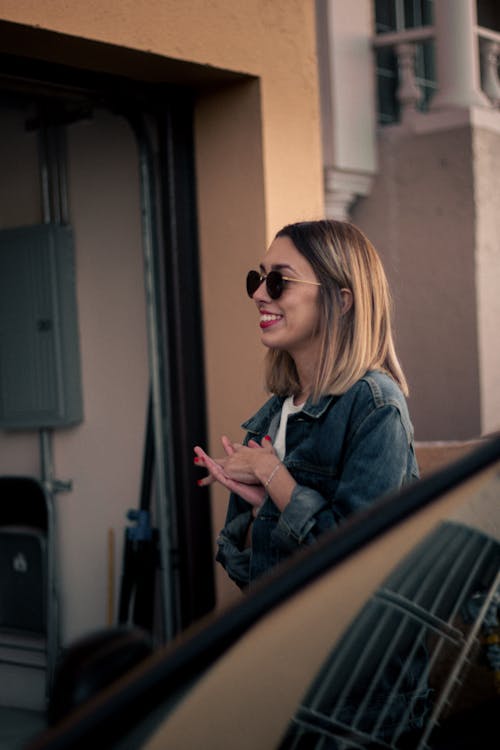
0 0 322 232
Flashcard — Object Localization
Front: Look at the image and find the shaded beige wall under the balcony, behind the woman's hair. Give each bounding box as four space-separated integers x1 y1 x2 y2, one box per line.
353 125 482 440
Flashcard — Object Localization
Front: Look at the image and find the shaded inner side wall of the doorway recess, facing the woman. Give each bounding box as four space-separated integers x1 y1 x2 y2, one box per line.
196 81 267 604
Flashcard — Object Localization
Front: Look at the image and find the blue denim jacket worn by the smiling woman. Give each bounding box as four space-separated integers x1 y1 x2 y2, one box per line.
216 371 418 588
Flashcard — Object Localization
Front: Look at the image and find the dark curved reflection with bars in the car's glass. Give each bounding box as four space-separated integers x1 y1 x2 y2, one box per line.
280 522 500 750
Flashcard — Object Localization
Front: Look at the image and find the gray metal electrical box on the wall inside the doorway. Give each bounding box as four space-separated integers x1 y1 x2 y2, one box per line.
0 224 83 429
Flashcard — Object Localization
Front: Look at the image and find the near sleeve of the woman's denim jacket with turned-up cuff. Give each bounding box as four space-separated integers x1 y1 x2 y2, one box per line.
273 403 418 552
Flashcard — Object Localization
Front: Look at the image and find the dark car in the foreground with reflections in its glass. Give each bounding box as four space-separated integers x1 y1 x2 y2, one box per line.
29 438 500 750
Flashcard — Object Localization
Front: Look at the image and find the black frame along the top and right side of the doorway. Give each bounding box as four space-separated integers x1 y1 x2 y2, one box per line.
0 44 215 637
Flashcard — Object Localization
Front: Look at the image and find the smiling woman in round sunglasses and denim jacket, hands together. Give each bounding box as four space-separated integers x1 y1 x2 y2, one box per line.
194 220 418 588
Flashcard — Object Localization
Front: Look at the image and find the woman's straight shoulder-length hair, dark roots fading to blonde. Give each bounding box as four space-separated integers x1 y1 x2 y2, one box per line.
266 220 408 400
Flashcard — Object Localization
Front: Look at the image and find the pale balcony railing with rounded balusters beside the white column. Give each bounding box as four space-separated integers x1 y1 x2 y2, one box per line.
373 26 500 122
